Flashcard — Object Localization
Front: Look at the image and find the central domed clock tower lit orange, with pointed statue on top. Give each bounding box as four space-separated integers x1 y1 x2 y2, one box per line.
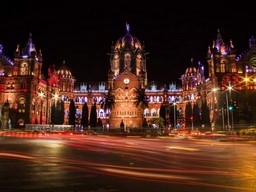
108 24 147 130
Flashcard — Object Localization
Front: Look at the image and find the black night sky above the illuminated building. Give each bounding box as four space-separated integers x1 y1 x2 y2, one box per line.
0 0 256 82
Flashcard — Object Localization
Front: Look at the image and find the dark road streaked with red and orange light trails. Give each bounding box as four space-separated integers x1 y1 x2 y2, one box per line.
0 135 256 192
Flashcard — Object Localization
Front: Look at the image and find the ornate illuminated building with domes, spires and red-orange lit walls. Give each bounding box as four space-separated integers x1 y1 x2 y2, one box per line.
0 24 256 130
